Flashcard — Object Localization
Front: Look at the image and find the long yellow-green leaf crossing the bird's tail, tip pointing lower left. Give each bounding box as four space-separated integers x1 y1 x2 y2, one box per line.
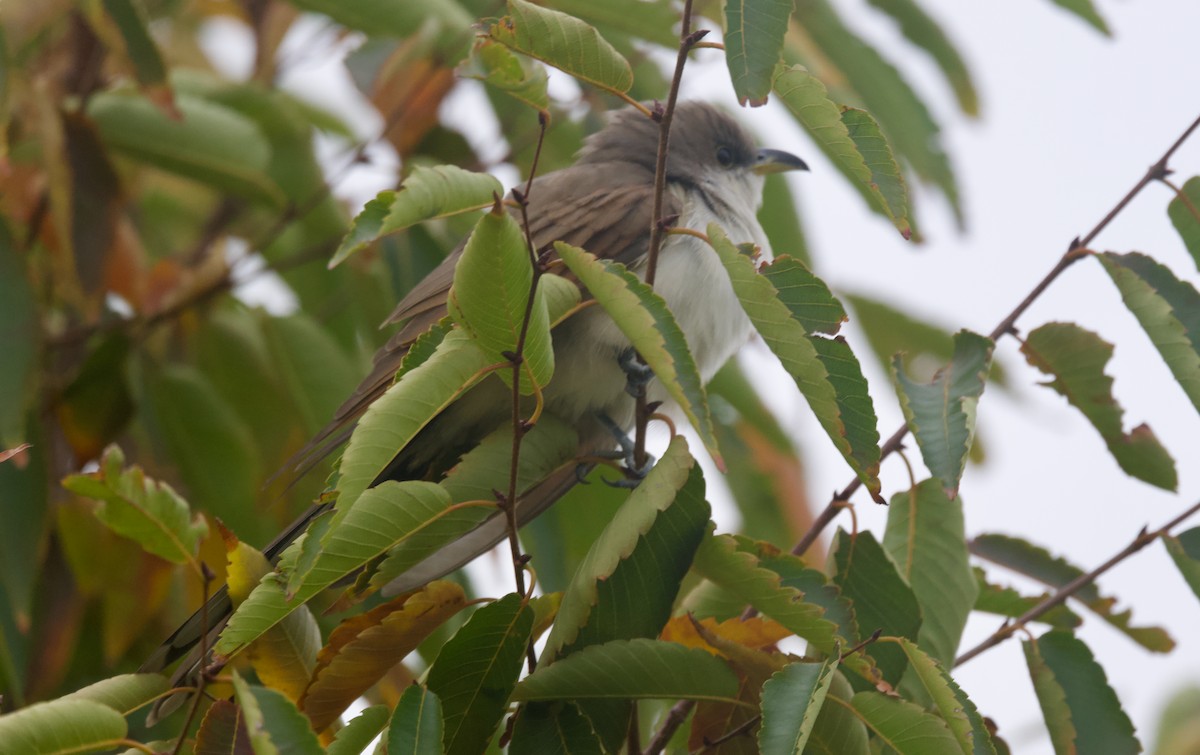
215 480 452 655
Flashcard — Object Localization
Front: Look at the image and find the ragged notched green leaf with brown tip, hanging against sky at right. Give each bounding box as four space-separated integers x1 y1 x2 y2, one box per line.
1021 323 1178 490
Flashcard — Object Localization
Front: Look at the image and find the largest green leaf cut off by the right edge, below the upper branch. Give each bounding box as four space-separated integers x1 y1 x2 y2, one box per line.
1097 252 1200 411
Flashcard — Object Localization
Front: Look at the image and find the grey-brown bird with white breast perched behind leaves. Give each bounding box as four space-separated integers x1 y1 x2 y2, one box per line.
142 102 806 691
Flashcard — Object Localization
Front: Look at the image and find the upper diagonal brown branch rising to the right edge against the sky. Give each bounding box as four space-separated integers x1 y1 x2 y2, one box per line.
792 111 1200 556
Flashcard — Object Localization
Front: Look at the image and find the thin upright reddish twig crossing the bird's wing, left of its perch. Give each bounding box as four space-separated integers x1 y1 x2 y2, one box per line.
497 110 550 673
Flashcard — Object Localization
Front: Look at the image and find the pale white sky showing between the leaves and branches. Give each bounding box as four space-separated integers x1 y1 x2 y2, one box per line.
208 0 1200 754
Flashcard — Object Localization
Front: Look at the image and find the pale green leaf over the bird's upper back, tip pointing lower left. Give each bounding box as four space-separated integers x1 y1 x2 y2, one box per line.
329 166 504 268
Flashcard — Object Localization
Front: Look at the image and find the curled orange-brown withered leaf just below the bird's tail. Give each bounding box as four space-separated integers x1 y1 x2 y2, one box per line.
300 581 467 732
